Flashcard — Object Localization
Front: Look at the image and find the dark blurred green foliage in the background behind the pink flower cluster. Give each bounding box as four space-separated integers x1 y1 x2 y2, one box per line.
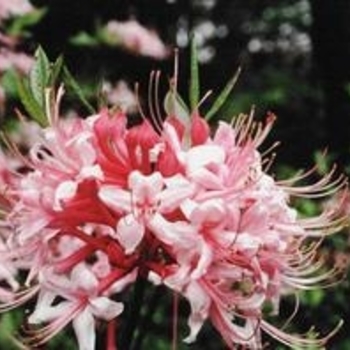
0 0 350 350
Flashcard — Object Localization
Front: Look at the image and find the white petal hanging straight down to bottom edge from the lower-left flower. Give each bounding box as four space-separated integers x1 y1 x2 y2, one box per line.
73 308 96 350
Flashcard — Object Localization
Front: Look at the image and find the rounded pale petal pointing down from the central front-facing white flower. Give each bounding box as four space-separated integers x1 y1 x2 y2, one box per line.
117 214 145 254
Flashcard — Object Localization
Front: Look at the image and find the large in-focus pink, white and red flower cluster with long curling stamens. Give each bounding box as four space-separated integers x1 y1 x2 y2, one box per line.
0 74 344 350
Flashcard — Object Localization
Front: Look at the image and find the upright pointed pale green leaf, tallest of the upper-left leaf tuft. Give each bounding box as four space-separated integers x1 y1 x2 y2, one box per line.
29 46 50 109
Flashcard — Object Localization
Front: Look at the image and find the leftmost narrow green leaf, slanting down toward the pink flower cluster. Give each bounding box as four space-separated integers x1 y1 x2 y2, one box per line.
17 78 48 126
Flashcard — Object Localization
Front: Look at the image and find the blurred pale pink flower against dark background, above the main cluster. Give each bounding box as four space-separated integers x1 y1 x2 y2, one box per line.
105 20 169 59
